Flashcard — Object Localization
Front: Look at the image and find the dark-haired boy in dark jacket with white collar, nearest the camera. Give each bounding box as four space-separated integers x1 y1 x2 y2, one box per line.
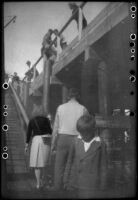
65 115 107 198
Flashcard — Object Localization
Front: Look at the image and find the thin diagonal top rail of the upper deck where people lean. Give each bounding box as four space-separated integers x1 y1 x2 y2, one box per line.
24 1 87 76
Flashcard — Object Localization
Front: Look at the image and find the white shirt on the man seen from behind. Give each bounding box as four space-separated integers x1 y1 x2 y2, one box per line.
53 100 87 135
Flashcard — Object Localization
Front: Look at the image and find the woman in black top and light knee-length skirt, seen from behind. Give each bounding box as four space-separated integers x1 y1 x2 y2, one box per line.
25 105 52 189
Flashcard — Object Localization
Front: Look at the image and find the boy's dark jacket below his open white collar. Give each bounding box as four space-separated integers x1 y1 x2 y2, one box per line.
65 138 107 190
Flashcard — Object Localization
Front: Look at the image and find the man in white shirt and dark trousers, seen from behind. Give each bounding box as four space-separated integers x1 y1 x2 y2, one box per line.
51 88 88 190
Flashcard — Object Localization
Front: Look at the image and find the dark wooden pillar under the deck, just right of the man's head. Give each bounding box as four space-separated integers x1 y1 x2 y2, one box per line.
81 46 99 113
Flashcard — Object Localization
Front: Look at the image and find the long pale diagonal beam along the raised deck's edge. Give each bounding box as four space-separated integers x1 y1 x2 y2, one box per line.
53 3 129 75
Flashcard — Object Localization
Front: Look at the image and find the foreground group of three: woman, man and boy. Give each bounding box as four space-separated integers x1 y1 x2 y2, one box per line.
25 88 107 198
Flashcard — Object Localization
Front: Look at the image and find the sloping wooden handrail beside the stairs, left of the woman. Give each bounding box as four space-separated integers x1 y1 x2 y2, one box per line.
9 83 29 125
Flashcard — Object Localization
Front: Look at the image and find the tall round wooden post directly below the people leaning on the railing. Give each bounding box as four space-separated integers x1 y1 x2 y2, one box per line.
43 54 51 114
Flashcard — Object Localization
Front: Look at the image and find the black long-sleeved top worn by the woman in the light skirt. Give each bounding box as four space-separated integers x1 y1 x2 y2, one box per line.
26 116 52 143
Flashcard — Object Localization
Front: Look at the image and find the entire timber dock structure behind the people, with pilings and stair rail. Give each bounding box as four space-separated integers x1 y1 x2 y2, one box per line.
2 2 136 197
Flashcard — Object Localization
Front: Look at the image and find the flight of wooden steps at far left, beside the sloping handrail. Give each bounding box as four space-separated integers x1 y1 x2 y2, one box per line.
5 90 27 174
